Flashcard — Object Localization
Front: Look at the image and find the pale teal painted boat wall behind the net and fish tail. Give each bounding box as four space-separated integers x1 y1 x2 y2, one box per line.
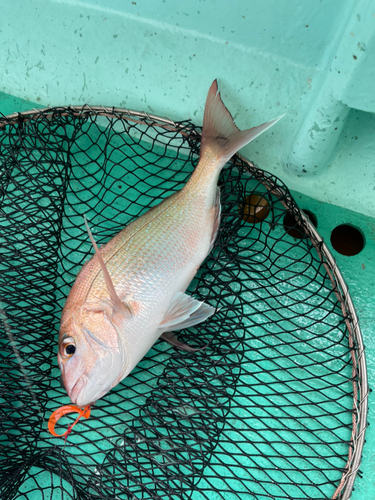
0 0 375 216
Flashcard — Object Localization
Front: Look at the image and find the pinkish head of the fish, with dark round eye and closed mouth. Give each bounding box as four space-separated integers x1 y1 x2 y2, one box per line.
57 311 128 407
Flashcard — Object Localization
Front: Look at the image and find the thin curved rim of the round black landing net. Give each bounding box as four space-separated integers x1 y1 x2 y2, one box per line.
0 104 369 500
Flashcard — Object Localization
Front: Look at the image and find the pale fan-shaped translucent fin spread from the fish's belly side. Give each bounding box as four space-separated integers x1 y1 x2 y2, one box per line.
159 292 215 332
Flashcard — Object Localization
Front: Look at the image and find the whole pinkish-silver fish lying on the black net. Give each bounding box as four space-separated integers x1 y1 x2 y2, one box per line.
57 80 281 407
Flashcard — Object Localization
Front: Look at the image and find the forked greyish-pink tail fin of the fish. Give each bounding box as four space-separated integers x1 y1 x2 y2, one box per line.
200 80 284 166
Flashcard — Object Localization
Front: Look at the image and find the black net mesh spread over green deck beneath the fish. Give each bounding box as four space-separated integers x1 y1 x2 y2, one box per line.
0 103 366 500
